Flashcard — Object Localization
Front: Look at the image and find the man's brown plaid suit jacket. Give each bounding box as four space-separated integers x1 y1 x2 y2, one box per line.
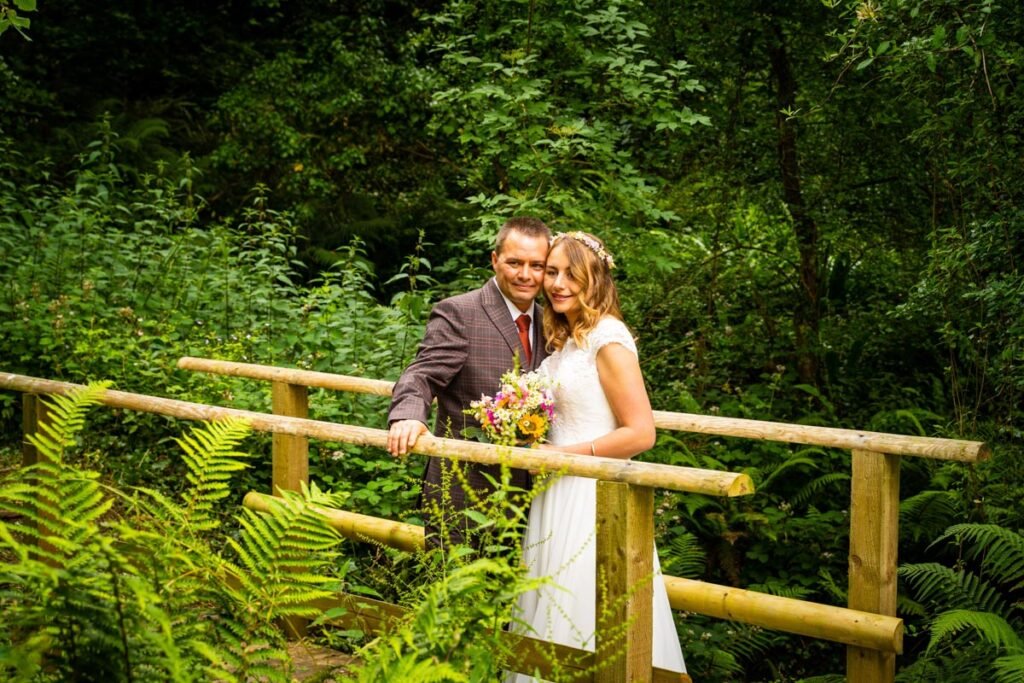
388 280 547 541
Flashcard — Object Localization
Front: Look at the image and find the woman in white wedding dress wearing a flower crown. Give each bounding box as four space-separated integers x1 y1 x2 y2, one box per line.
507 231 686 683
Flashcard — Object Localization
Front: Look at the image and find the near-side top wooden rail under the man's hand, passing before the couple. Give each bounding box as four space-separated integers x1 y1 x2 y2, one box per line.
0 373 754 496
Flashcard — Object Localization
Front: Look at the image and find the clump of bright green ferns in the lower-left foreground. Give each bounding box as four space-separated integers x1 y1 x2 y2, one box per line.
0 385 338 683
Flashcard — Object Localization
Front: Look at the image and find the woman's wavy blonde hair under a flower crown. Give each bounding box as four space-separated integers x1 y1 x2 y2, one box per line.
544 231 623 351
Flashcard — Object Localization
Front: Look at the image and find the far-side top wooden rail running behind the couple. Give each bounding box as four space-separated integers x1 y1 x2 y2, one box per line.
178 356 989 462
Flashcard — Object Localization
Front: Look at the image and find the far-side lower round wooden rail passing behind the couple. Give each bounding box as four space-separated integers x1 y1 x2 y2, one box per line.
243 492 903 654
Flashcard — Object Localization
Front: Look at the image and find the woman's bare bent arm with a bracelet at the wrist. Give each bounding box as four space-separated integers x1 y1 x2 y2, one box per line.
549 343 654 458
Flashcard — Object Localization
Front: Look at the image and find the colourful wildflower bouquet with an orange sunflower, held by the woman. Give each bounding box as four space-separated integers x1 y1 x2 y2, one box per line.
463 355 555 445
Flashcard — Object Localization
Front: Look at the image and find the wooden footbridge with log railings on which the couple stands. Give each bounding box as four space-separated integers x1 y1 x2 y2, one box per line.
0 357 988 683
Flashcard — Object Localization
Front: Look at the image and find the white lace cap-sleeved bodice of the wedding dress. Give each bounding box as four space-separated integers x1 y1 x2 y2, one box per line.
540 317 637 445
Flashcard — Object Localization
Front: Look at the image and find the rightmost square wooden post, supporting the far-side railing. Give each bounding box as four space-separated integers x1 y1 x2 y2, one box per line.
846 451 900 683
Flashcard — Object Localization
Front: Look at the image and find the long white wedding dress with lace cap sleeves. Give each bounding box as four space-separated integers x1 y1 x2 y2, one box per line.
506 317 686 683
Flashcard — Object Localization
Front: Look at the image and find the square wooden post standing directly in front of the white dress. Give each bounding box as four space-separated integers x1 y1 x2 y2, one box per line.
594 481 660 683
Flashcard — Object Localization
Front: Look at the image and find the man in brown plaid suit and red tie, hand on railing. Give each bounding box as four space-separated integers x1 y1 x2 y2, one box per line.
387 216 551 547
